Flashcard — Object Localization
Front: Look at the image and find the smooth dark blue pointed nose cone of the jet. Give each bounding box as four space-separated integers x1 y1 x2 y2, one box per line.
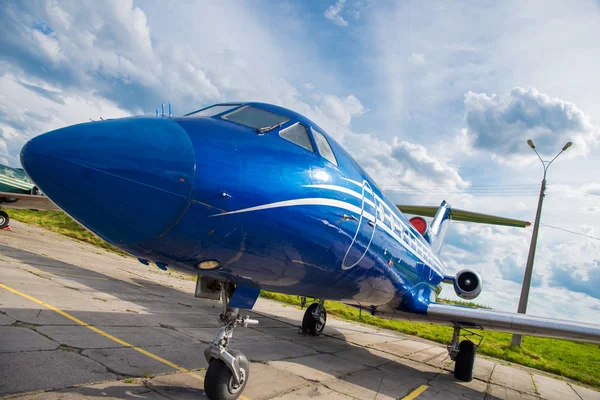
21 117 195 246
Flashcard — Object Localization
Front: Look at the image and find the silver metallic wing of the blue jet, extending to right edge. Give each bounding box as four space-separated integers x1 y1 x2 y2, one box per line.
427 303 600 343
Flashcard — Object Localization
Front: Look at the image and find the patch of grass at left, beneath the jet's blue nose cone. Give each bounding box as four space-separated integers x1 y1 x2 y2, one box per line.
10 210 127 256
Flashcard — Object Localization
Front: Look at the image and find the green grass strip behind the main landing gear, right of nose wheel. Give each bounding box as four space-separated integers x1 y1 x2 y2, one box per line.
261 291 600 388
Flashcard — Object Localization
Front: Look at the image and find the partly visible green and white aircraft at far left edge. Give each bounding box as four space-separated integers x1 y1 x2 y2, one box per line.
0 164 59 229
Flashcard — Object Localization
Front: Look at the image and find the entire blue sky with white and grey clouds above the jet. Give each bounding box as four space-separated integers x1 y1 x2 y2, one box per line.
0 0 600 323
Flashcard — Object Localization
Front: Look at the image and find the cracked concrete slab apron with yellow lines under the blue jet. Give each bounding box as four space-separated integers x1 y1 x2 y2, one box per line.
0 222 600 400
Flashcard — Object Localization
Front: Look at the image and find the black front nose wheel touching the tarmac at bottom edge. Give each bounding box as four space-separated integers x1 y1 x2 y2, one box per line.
204 350 250 400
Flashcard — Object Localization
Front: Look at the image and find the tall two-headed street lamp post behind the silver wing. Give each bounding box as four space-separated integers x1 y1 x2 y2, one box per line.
512 139 573 347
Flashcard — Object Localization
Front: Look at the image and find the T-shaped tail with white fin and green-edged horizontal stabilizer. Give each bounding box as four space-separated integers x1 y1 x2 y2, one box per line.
396 200 531 252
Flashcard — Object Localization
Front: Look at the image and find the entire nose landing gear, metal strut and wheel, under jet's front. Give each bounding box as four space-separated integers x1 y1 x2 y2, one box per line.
204 283 258 400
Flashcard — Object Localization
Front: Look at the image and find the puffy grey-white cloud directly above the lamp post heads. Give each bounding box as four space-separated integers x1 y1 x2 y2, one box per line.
461 88 600 165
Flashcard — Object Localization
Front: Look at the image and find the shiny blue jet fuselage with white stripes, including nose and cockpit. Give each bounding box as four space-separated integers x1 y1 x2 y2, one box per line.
21 103 445 313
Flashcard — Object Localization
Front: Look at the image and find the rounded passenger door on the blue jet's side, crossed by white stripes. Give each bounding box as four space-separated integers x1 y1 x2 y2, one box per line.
342 180 379 269
